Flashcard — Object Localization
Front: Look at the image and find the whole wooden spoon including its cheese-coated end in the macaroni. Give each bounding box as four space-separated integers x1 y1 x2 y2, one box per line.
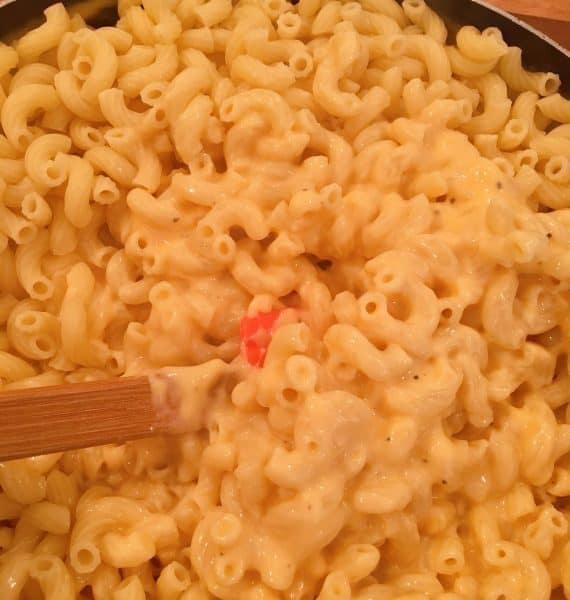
0 359 236 461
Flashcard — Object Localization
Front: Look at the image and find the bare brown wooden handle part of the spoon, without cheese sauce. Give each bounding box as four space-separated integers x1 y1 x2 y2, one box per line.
0 376 155 461
